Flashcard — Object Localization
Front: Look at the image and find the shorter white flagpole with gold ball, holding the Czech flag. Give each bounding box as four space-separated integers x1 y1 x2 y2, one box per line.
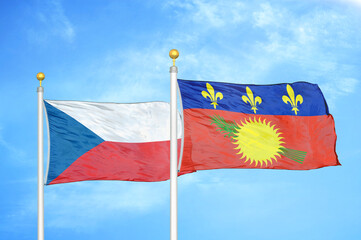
36 72 45 240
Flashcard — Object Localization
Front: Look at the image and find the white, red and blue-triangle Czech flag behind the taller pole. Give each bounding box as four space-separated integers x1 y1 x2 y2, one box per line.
44 100 186 185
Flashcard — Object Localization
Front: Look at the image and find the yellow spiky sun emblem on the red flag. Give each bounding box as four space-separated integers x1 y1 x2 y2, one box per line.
232 118 284 167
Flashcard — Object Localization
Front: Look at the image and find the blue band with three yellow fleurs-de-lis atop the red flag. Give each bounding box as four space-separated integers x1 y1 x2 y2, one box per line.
178 79 329 116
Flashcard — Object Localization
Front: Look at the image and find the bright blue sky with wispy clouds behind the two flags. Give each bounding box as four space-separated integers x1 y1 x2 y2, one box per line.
0 0 361 240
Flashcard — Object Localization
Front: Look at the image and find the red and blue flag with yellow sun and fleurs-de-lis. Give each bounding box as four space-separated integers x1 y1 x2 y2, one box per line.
178 80 340 171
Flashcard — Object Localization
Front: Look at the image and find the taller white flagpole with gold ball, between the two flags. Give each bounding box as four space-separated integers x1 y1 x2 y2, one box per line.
169 49 179 240
